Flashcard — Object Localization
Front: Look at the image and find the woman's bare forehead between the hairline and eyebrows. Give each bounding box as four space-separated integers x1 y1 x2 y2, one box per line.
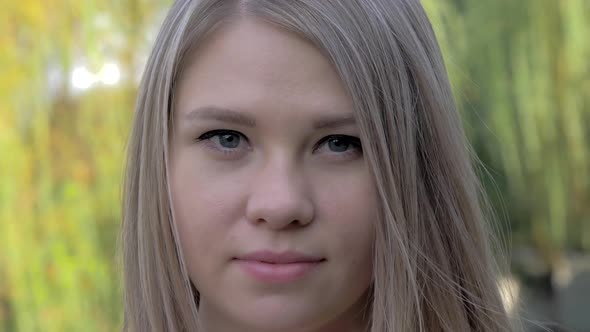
175 19 352 125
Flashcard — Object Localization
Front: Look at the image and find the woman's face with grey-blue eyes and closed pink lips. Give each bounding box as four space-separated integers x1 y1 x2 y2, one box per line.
171 19 377 332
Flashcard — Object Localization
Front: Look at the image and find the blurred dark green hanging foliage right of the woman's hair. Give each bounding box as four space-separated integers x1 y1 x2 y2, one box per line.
425 0 590 264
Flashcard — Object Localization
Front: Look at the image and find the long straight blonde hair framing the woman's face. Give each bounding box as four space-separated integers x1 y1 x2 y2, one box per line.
121 0 511 332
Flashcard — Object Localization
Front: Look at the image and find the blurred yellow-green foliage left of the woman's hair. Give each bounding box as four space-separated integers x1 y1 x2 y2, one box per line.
0 0 167 331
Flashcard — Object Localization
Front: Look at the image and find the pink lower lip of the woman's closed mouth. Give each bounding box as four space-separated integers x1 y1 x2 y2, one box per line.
237 260 324 283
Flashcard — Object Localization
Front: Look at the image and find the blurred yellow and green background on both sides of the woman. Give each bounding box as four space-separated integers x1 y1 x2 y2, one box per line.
0 0 590 332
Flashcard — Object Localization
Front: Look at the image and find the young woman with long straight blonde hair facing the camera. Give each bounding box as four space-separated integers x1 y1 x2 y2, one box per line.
122 0 510 332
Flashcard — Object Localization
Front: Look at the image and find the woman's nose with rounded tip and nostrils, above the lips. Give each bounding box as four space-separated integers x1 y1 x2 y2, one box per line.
246 160 314 230
